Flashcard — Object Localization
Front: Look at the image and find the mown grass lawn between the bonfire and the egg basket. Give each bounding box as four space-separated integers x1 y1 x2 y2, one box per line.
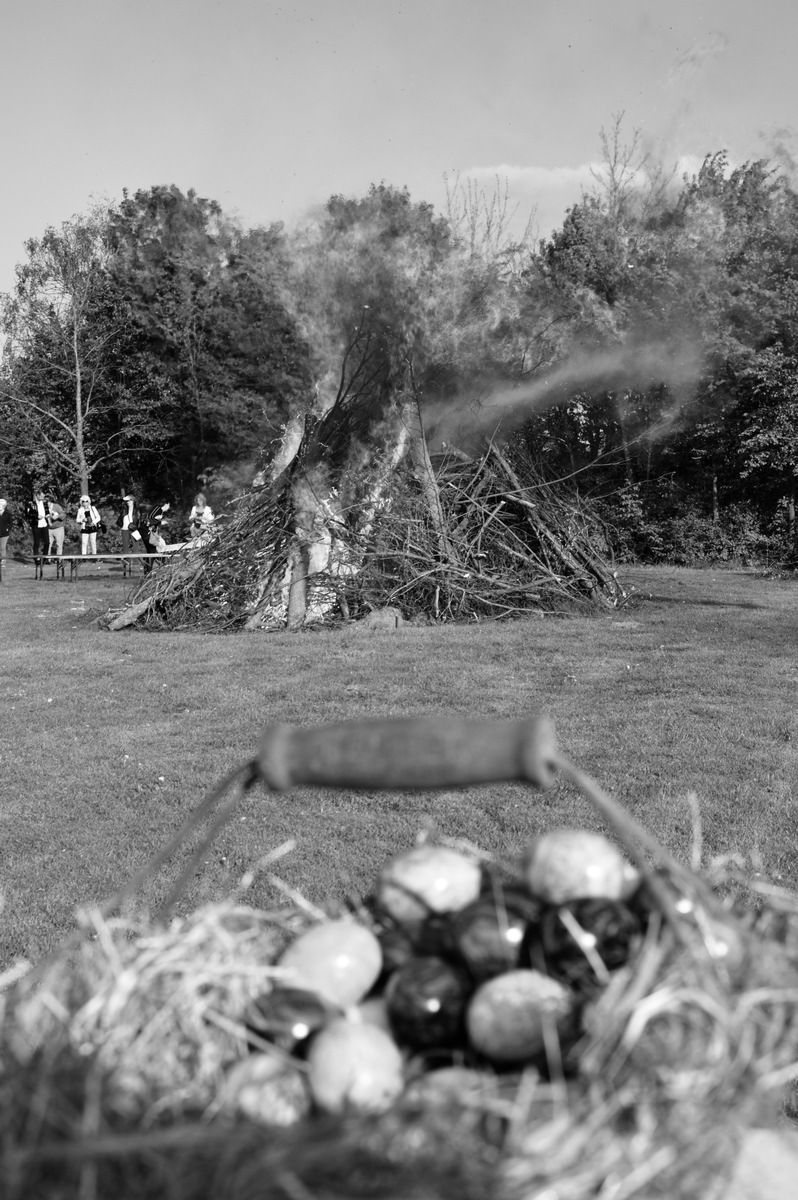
0 563 798 965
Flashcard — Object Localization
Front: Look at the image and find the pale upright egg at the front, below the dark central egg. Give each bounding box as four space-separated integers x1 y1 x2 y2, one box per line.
307 1018 404 1112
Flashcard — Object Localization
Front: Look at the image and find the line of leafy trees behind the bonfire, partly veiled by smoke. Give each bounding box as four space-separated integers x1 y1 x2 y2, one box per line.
0 120 798 560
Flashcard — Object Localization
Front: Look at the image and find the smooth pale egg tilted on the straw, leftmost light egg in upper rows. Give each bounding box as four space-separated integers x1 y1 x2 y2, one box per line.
280 920 383 1008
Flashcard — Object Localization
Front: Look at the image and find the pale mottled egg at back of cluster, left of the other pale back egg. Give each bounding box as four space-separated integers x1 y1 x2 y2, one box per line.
377 845 482 926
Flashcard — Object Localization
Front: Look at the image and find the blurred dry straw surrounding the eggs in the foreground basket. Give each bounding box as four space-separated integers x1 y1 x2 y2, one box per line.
0 725 798 1200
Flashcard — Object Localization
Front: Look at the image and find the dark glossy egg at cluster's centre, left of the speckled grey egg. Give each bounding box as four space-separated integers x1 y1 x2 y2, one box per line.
385 955 473 1050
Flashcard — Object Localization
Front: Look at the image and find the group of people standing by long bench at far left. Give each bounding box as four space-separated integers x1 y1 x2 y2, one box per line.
0 490 216 571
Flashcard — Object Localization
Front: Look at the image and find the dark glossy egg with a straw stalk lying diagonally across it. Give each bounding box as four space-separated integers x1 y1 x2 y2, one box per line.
524 898 642 991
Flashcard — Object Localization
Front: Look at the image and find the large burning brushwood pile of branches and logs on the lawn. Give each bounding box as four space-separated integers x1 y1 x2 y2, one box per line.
110 443 625 630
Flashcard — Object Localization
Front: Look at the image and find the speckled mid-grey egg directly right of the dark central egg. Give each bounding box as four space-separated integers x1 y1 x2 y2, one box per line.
466 970 574 1066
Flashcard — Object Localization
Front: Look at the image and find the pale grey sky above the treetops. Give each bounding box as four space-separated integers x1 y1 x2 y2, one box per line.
0 0 798 290
